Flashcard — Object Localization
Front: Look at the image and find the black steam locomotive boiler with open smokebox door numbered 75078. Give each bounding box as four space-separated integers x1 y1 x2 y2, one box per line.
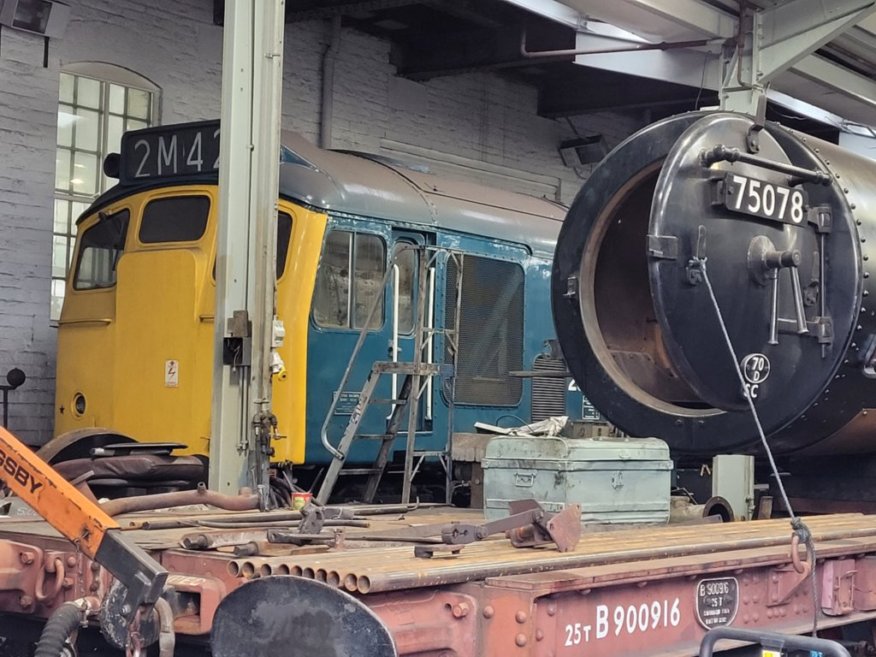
552 113 876 456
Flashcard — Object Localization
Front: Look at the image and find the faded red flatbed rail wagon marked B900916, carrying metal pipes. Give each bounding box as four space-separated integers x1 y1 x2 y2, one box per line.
0 507 876 657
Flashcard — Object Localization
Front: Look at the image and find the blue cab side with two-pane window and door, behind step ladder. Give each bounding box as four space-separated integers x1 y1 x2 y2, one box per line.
307 222 434 464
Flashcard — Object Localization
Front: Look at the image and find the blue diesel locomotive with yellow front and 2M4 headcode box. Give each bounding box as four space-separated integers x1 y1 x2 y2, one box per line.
44 122 582 494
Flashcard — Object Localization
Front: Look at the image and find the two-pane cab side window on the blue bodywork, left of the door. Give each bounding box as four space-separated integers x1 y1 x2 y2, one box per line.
313 230 386 329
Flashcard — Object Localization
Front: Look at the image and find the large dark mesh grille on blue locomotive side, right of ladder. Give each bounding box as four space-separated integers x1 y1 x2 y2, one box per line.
444 255 523 406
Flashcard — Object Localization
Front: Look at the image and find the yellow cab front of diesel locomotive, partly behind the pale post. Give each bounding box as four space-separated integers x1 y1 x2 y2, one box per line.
55 185 326 463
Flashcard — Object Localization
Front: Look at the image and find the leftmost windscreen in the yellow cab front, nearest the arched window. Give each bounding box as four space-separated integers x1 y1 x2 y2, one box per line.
73 210 131 290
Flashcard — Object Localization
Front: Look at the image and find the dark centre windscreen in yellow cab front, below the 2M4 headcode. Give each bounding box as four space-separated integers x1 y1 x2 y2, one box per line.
140 196 210 244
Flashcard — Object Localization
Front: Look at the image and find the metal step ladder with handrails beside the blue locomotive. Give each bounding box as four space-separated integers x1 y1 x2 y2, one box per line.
316 245 462 504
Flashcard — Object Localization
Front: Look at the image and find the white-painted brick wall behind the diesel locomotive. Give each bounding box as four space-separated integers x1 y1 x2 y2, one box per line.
0 0 639 444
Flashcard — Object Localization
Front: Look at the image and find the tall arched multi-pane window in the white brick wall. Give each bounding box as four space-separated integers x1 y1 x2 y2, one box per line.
51 63 159 320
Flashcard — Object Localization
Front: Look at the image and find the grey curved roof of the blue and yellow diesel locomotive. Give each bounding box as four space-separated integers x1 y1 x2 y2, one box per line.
88 124 566 254
